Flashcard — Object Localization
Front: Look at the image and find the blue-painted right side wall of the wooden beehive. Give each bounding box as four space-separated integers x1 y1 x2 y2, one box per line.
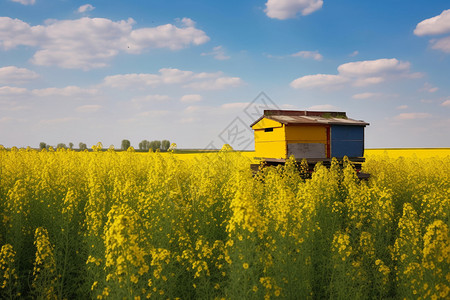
331 125 364 158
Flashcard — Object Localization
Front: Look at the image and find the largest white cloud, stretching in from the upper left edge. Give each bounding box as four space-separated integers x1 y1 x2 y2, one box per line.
0 17 209 70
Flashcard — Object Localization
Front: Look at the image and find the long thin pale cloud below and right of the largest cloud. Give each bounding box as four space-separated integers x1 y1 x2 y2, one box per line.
104 68 243 90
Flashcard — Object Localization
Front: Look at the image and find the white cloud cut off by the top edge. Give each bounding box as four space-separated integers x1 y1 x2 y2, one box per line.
264 0 323 20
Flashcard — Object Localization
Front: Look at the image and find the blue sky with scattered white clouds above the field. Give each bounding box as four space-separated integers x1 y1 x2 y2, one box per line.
0 0 450 149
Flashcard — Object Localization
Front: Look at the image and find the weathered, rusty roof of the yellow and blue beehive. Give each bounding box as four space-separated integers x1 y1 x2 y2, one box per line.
250 110 369 127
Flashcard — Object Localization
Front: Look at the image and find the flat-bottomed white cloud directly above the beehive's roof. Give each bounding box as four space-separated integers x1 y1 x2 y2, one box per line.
291 58 421 88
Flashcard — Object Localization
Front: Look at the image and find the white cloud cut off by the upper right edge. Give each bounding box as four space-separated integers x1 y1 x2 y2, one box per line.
414 9 450 53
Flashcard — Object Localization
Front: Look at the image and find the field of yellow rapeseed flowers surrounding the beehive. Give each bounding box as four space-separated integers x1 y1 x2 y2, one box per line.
0 147 450 299
